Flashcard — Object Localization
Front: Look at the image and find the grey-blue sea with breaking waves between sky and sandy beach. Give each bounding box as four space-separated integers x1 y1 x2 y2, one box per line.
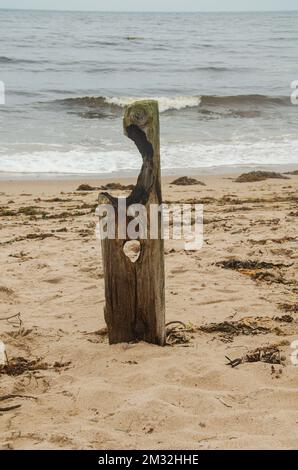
0 10 298 177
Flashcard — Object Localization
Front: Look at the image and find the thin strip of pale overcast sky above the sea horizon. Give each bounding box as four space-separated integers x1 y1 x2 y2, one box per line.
0 0 298 11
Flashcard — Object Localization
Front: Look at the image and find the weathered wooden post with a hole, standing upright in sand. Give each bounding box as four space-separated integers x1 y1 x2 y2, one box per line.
99 100 165 345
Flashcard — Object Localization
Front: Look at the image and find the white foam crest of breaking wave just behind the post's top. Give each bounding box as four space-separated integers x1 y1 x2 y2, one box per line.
105 96 201 113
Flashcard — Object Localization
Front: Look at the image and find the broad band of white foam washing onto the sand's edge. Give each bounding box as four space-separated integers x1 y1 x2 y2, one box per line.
0 140 298 175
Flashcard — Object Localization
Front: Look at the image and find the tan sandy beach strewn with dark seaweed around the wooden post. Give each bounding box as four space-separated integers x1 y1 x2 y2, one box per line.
0 175 298 449
